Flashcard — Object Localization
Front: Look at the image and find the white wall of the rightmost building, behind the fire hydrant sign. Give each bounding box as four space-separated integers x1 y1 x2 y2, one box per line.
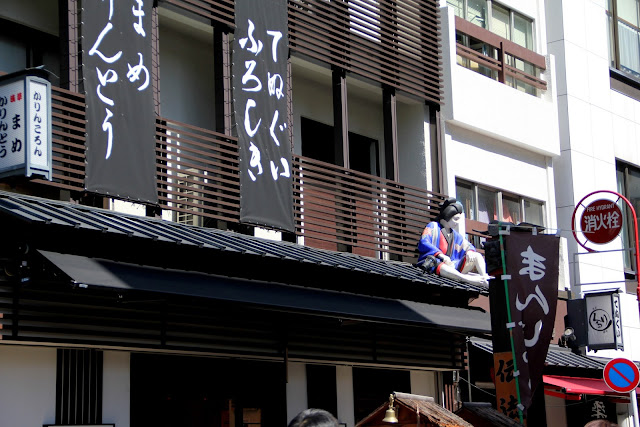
547 0 640 300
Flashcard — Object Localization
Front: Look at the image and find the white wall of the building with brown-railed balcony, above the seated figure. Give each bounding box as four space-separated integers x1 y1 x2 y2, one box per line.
441 1 560 229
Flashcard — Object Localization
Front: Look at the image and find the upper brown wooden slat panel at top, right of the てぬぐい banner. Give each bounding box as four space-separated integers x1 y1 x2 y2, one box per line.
289 0 442 104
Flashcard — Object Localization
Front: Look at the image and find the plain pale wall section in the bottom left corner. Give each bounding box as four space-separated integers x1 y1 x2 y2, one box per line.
0 345 56 426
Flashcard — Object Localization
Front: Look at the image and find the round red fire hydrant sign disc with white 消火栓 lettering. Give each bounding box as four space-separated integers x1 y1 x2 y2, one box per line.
580 199 622 244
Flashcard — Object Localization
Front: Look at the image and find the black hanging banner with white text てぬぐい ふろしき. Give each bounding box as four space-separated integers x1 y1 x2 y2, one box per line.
232 0 295 231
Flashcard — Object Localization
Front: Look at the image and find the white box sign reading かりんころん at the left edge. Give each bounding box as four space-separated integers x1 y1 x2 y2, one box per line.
0 72 52 180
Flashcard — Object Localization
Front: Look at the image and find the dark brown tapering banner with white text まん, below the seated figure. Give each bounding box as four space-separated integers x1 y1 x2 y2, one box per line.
503 232 560 411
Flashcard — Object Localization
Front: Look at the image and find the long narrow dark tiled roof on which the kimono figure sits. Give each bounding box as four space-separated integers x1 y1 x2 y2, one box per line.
0 192 488 295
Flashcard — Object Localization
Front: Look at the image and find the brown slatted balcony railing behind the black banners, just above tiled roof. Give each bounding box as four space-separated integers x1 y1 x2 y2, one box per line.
35 87 444 261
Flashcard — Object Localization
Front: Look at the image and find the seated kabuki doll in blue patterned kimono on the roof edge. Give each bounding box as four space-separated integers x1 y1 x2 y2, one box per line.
416 198 491 285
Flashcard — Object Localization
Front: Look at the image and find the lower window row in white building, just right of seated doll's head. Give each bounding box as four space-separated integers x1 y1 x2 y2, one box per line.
456 180 544 225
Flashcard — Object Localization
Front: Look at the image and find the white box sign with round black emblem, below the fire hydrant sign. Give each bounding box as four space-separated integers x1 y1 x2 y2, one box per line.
584 292 624 350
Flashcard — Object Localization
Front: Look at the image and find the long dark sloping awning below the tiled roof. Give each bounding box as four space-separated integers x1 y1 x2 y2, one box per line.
39 250 491 334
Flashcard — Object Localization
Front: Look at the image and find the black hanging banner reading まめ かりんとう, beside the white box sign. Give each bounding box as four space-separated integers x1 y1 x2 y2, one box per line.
81 0 158 203
